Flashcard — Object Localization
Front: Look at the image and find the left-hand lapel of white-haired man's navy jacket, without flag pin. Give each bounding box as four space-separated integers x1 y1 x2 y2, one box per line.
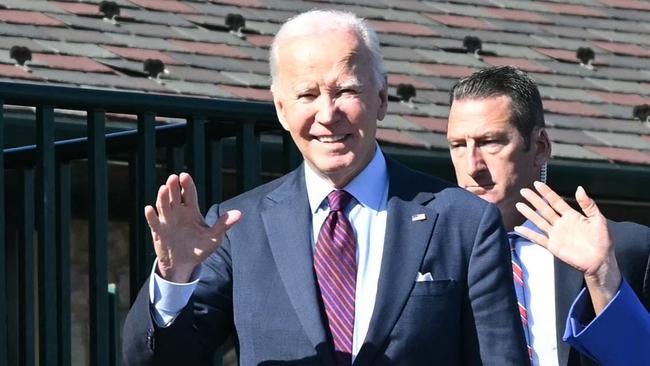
262 168 333 364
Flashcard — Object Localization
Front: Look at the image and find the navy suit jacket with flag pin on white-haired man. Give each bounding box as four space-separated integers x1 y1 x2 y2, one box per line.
123 159 528 366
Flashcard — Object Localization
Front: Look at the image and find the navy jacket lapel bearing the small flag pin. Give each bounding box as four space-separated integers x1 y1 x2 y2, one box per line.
354 160 438 365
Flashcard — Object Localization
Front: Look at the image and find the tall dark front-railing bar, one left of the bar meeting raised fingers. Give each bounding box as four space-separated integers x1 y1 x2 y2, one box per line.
88 110 109 366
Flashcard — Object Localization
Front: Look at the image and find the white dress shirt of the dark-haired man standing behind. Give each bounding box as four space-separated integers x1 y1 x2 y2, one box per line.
511 221 559 366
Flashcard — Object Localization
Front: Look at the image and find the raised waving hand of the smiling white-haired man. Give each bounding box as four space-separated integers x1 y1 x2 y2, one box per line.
144 173 241 282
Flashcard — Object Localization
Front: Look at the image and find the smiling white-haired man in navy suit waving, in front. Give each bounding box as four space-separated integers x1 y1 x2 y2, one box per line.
124 11 528 366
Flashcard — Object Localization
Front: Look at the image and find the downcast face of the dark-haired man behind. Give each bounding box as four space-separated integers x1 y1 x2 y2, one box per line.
447 96 542 219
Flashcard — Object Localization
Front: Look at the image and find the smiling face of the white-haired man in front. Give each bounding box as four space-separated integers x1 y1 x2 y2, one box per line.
273 30 387 187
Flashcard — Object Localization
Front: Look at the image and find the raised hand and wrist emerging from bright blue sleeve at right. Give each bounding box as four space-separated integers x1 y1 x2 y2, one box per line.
515 182 622 314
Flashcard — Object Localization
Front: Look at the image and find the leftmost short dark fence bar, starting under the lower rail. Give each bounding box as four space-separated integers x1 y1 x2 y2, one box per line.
17 168 36 366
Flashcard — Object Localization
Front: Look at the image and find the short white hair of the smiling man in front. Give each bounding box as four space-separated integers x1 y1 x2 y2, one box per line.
269 10 386 92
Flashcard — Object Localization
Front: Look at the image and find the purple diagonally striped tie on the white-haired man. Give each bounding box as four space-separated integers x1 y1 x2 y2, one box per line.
314 190 357 366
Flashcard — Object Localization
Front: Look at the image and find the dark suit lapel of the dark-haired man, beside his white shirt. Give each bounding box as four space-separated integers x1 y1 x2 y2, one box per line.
554 258 583 366
